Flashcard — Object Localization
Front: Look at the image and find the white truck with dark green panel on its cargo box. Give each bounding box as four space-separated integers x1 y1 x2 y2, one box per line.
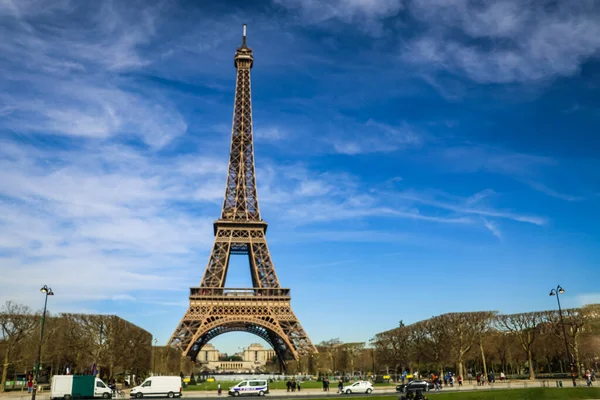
50 375 112 400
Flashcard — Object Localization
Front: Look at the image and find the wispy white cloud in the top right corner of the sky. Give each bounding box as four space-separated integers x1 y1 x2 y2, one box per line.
402 0 600 83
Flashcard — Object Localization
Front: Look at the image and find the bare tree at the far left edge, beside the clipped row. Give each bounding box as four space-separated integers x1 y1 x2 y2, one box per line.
0 301 38 392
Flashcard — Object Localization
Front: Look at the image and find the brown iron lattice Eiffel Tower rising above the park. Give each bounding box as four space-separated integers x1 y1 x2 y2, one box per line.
169 25 317 371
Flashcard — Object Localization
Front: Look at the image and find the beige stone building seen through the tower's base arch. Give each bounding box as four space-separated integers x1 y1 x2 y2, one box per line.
196 343 275 373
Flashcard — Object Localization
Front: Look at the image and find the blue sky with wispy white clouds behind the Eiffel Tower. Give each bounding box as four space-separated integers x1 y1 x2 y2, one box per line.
0 0 600 352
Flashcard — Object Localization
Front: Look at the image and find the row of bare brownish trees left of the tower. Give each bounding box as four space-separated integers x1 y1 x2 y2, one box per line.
0 301 152 390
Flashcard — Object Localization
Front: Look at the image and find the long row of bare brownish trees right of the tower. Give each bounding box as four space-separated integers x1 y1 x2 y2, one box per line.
372 304 600 379
